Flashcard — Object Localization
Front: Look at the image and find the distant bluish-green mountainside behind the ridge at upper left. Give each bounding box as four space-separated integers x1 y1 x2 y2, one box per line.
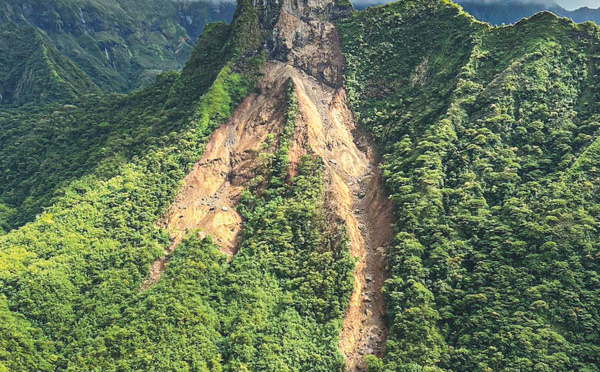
0 0 235 105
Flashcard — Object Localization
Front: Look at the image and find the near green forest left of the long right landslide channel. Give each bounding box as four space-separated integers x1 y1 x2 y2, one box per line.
0 4 354 372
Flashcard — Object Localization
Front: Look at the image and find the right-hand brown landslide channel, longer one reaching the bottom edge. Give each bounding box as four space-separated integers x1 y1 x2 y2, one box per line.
290 70 393 371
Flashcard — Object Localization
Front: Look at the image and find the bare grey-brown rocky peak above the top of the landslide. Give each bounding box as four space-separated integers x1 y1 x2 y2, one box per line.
253 0 352 87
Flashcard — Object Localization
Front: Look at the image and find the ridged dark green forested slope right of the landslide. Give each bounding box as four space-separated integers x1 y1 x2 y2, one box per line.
339 0 600 371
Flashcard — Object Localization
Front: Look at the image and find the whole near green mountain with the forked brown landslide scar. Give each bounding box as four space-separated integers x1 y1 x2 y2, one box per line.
0 0 600 372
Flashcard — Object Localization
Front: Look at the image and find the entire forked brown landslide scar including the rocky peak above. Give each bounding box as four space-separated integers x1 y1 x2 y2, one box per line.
141 1 393 366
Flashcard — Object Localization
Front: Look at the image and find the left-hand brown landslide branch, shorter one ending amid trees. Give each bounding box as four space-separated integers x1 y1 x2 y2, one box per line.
140 64 289 291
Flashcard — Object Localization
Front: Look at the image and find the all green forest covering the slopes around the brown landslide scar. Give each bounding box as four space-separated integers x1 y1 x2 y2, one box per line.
0 0 600 372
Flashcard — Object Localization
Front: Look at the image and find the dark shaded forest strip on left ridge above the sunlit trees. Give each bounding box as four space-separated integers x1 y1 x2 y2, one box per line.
0 18 240 231
